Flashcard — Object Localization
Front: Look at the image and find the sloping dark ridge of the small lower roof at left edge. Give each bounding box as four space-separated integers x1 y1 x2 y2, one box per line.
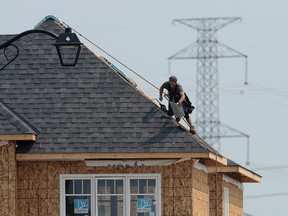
0 99 40 135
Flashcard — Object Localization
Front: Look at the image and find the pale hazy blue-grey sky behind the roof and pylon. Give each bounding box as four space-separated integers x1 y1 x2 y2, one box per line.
0 0 288 216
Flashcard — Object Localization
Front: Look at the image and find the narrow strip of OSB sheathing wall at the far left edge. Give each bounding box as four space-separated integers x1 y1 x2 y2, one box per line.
0 141 17 216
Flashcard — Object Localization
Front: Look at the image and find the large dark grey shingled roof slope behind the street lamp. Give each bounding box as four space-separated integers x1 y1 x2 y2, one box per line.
0 17 217 153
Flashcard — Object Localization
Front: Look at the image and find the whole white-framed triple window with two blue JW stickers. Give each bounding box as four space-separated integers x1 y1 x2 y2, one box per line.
60 174 161 216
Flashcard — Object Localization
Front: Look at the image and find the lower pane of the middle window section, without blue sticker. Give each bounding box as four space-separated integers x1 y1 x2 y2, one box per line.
97 196 124 216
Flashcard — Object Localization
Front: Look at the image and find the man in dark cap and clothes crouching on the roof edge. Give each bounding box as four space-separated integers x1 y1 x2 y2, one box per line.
159 76 196 134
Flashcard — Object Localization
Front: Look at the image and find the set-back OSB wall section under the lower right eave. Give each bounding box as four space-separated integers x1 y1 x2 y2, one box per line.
208 173 244 216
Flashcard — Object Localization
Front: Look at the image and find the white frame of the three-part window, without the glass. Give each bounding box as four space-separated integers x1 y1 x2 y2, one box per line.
60 173 162 216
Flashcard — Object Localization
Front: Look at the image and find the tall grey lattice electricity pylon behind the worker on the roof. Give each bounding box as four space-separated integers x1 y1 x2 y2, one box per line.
168 17 249 155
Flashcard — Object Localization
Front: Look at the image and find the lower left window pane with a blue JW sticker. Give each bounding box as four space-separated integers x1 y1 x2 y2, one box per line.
66 196 91 216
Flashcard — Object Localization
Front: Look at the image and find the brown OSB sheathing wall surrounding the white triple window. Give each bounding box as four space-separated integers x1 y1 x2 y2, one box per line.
17 160 208 216
